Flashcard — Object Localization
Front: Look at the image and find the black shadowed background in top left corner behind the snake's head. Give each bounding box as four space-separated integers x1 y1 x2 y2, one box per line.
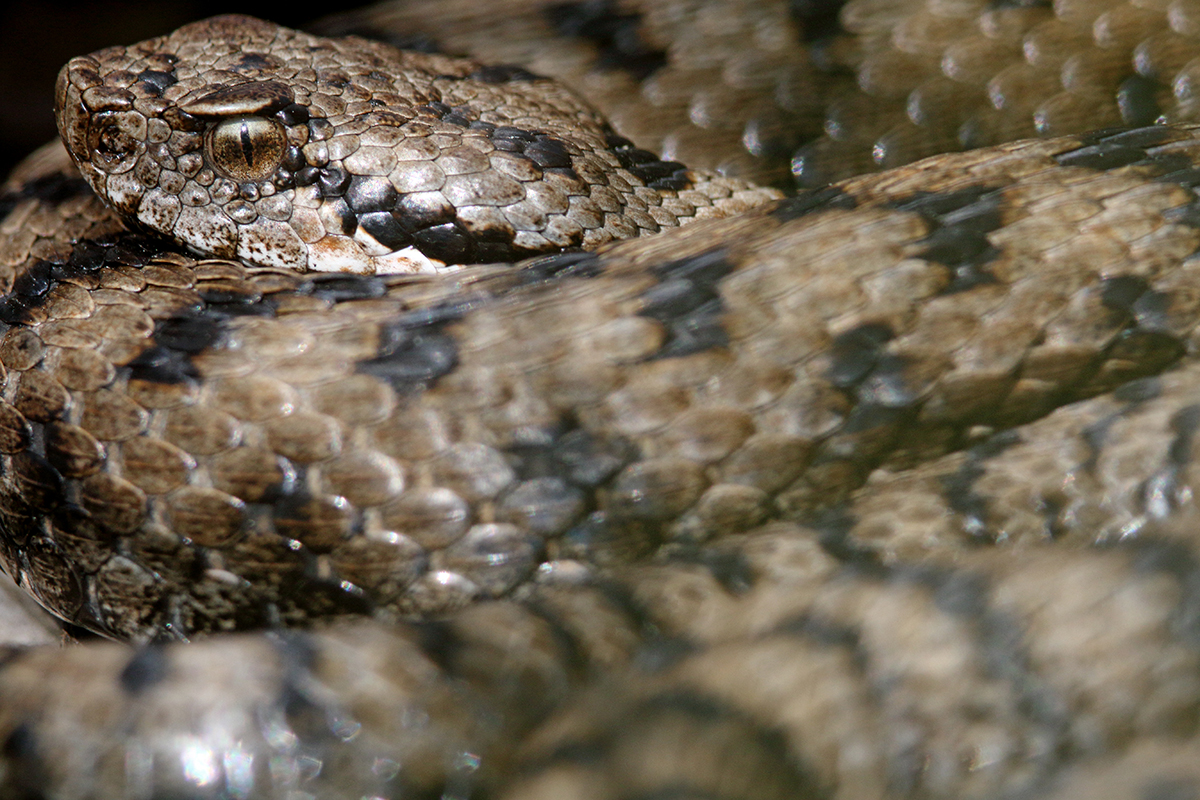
0 0 376 176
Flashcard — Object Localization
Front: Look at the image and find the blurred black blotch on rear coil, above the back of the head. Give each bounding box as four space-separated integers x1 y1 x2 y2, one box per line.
546 0 667 80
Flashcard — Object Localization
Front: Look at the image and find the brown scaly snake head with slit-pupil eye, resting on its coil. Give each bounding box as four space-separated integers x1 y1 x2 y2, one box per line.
56 16 736 273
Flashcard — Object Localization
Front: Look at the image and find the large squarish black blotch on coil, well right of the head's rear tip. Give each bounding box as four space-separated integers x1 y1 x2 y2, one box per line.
888 186 1003 294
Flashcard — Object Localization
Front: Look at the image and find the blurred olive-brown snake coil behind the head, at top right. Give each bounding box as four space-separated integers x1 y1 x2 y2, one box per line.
326 0 1200 186
